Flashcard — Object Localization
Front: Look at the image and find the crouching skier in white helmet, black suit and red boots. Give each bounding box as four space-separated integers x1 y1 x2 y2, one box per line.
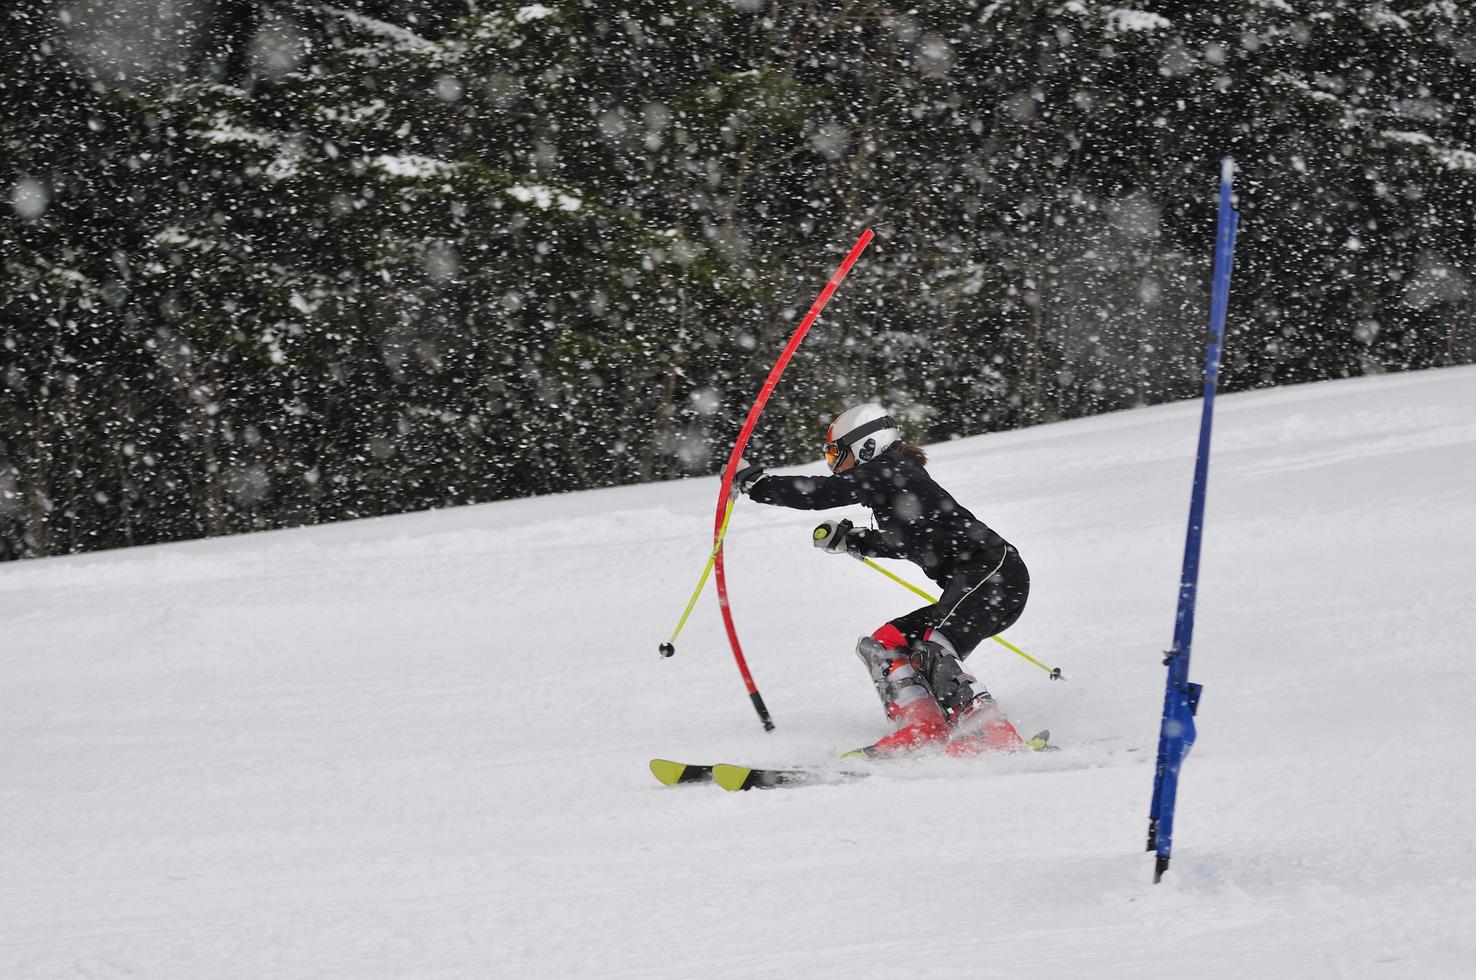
734 404 1030 756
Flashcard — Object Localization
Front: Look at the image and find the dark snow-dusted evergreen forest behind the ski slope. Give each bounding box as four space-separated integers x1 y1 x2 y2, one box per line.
0 0 1476 558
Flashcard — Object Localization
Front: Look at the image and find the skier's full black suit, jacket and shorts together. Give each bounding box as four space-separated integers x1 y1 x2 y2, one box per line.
748 449 1030 657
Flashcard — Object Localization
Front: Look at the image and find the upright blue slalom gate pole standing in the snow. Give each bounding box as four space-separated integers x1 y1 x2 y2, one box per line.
1148 156 1240 883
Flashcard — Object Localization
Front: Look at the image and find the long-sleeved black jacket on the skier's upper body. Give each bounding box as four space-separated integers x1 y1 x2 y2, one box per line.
748 449 1013 587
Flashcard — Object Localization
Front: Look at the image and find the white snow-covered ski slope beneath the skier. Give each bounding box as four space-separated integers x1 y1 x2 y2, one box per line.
0 368 1476 980
